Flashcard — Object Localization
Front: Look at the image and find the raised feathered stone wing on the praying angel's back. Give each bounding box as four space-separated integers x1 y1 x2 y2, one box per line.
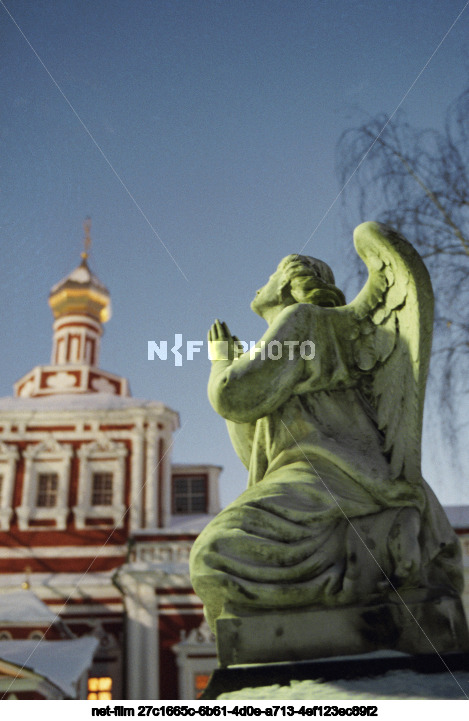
338 223 433 481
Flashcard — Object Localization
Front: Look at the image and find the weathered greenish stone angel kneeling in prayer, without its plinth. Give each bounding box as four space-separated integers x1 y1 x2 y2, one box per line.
191 223 467 650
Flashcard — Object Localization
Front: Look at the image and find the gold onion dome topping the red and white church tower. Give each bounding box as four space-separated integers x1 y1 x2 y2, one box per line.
49 252 111 323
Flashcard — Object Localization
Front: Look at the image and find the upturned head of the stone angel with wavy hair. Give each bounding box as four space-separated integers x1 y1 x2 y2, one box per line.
251 254 345 320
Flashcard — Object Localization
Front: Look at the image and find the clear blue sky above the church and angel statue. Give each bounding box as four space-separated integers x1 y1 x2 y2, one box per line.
0 0 469 503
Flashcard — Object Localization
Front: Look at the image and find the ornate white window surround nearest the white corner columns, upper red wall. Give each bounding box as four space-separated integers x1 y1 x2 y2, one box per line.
73 434 127 530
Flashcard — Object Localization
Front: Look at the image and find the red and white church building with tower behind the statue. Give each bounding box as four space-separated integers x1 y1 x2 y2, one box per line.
0 246 221 699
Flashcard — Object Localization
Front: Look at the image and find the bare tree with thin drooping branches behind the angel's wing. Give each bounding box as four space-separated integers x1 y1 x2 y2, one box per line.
337 88 469 445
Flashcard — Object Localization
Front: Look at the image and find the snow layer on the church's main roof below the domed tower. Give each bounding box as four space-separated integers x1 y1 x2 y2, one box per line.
0 393 175 413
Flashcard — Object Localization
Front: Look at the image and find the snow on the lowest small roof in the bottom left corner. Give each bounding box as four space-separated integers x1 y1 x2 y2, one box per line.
0 636 99 698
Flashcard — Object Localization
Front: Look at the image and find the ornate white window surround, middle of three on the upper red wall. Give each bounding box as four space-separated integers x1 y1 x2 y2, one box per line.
16 438 73 531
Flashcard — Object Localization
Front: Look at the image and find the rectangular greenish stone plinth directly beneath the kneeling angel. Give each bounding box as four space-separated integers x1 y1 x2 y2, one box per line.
216 597 469 667
